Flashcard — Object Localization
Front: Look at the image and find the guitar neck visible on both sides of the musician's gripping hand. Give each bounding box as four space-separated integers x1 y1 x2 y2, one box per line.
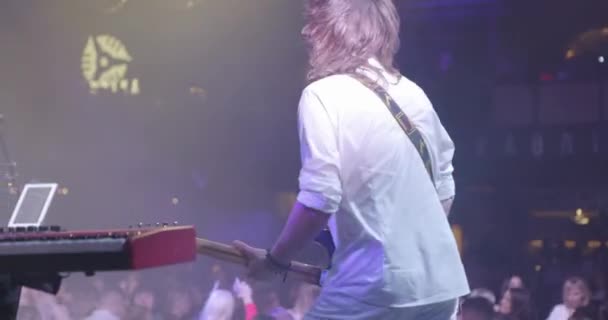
196 238 323 285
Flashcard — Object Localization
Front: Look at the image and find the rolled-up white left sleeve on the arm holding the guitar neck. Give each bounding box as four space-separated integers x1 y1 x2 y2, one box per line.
298 88 342 214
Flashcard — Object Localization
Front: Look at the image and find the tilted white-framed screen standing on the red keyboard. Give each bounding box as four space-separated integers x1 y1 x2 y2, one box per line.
8 183 57 227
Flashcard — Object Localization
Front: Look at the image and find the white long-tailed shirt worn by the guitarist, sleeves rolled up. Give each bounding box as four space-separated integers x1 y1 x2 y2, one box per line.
298 61 469 318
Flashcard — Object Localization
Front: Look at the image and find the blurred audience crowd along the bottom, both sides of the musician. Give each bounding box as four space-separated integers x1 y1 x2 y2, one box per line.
18 264 608 320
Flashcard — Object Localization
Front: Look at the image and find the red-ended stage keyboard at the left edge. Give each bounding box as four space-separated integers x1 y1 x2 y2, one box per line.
0 226 196 273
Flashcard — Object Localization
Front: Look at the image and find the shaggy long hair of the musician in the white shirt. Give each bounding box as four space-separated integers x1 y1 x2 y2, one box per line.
302 0 400 81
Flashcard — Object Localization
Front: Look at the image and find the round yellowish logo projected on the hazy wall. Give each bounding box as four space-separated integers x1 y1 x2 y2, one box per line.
81 34 140 95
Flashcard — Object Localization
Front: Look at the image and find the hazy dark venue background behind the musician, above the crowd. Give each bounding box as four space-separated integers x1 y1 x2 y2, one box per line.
0 0 608 308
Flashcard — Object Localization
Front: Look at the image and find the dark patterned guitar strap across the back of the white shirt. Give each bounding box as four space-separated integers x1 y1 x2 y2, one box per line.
361 81 435 185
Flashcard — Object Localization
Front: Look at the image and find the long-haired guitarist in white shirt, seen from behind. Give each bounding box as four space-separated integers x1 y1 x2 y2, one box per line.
235 0 469 320
